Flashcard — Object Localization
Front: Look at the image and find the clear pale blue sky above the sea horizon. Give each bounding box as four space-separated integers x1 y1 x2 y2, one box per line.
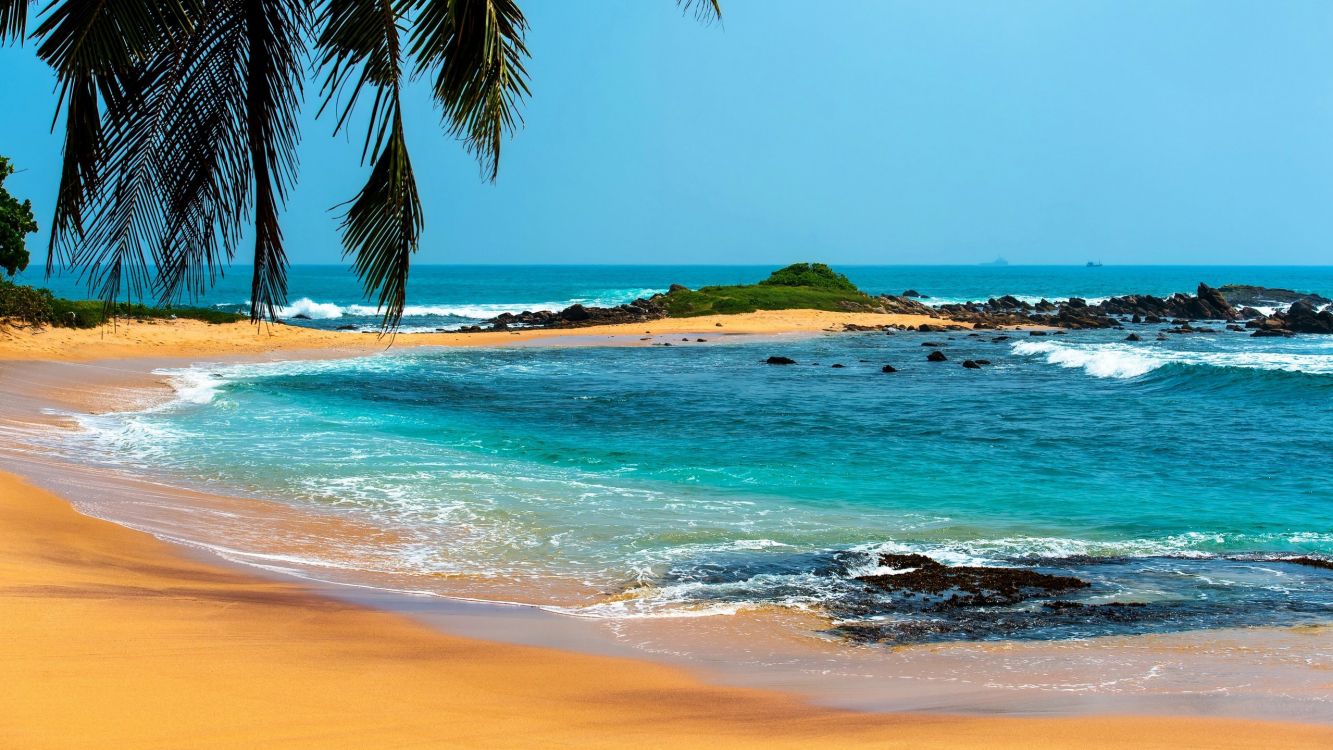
0 0 1333 264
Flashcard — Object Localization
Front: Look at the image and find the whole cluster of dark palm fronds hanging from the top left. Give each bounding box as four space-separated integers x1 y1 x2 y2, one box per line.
0 0 721 328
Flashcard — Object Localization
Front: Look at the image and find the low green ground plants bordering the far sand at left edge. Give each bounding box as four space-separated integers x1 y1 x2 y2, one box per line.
0 278 245 328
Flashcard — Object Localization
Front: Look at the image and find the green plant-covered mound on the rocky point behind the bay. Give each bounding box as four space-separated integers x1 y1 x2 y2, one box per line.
665 262 874 317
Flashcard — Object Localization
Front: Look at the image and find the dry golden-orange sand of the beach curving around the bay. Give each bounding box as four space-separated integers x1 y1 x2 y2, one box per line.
0 312 1333 747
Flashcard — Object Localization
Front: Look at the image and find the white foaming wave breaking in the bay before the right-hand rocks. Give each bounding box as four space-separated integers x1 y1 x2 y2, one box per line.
1012 341 1333 378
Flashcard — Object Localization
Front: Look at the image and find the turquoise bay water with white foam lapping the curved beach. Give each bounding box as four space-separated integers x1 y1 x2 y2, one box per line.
67 269 1333 642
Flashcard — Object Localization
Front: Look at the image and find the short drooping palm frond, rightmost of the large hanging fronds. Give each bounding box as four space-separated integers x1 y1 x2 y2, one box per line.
411 0 531 180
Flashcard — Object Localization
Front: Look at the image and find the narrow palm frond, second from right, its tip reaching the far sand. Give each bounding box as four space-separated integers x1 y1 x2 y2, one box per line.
317 0 423 329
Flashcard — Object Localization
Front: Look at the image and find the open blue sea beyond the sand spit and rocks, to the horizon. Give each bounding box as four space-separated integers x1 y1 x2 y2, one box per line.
21 265 1333 330
